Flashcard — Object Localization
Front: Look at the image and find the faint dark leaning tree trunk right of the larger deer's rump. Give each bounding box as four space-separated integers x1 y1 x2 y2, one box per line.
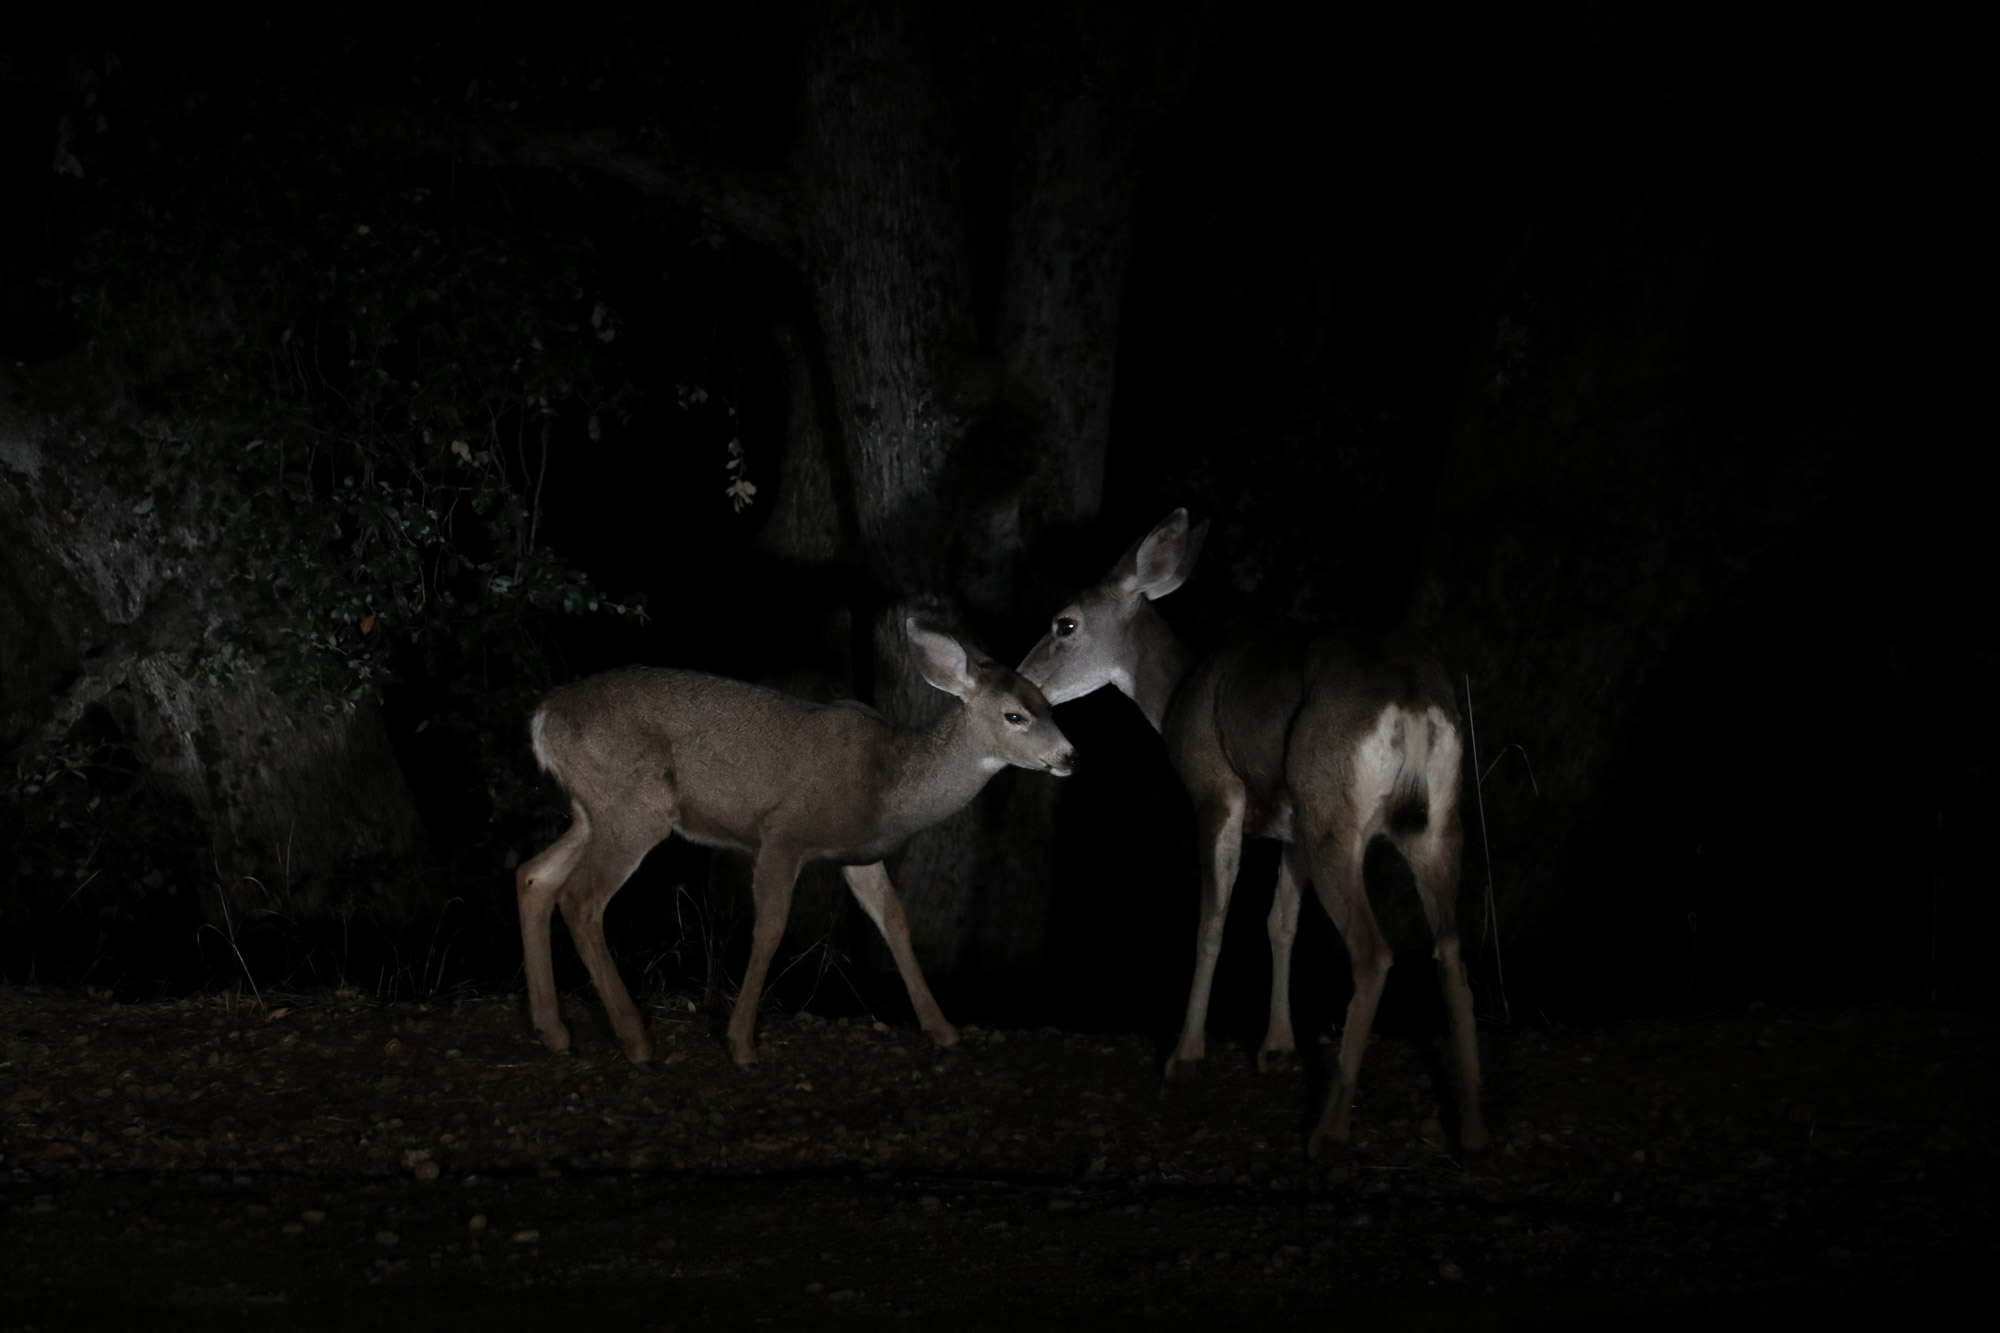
1412 182 1832 956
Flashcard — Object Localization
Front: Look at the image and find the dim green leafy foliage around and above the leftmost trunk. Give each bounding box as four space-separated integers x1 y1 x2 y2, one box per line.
0 31 756 976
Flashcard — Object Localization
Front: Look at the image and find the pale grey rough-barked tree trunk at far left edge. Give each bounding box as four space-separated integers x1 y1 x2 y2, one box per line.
0 358 426 925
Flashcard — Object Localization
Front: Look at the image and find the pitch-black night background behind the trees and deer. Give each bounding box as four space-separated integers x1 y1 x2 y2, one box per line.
0 8 2000 1037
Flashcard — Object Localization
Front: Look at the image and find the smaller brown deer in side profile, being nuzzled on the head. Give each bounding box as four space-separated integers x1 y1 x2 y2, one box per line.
514 616 1076 1067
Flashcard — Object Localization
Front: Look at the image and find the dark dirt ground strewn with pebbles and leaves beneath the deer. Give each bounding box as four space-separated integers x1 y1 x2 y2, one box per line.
0 987 2000 1333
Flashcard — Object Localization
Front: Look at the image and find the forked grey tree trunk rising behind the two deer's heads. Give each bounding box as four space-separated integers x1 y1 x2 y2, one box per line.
748 6 1146 975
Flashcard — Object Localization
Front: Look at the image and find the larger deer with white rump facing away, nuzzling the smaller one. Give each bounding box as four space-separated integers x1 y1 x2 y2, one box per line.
1018 508 1488 1157
